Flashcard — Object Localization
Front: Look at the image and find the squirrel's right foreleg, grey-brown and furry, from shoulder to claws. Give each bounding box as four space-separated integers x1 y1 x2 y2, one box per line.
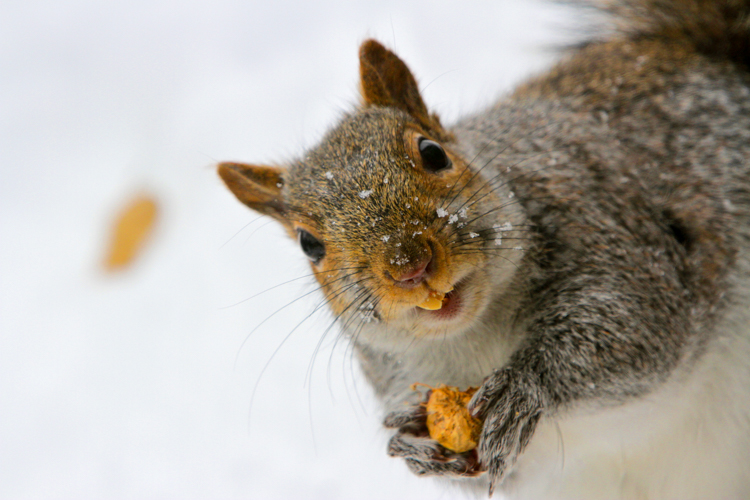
468 270 700 491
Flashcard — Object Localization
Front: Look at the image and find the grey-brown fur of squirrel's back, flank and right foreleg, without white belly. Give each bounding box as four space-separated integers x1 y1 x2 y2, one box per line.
376 2 750 496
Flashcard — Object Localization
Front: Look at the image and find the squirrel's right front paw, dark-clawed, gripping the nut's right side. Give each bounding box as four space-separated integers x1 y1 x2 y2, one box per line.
468 368 544 495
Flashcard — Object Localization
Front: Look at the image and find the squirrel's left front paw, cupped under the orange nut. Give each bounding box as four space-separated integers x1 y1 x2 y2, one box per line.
383 405 484 477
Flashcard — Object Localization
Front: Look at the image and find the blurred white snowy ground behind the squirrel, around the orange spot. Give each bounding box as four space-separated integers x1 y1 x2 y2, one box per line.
0 0 570 500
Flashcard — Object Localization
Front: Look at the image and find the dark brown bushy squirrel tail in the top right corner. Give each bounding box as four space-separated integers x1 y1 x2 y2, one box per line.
590 0 750 68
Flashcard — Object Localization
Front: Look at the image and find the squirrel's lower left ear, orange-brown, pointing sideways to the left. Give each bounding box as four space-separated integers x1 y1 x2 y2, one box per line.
218 162 287 223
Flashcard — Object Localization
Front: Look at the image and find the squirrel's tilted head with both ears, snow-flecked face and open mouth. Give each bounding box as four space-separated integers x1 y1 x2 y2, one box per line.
218 40 520 342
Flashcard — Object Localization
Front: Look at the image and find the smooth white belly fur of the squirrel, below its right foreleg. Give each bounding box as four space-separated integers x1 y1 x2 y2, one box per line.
503 280 750 500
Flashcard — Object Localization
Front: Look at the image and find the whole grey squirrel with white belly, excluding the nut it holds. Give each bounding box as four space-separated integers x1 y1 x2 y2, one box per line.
218 0 750 499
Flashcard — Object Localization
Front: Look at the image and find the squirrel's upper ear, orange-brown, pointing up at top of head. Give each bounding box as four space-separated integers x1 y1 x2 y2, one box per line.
359 40 440 129
